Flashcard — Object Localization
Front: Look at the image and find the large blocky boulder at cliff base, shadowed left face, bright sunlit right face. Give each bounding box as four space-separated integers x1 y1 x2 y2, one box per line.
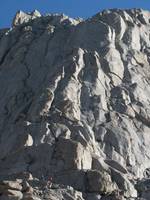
54 138 92 171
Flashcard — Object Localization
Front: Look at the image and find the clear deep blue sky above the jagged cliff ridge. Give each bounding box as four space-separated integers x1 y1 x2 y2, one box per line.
0 0 150 28
